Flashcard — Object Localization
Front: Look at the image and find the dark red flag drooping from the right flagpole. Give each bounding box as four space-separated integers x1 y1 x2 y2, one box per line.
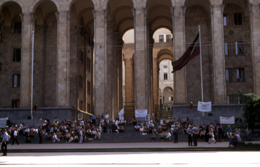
172 33 200 72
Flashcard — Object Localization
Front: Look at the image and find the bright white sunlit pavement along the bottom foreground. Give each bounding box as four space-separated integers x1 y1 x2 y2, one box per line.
0 151 260 167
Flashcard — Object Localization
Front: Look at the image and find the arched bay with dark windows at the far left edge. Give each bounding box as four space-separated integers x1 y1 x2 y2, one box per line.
0 1 24 108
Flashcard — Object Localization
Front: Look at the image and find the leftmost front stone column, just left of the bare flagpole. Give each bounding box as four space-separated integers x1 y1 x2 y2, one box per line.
20 13 34 108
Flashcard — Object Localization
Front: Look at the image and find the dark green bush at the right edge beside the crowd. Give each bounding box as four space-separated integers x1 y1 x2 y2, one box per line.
240 93 260 129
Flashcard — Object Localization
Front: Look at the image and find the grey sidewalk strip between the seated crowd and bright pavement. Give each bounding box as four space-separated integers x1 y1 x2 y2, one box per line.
8 141 260 153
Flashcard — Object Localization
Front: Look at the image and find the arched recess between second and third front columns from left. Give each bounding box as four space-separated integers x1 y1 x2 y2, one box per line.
70 0 94 113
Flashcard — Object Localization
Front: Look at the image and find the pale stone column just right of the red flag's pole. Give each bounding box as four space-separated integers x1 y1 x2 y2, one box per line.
211 4 226 104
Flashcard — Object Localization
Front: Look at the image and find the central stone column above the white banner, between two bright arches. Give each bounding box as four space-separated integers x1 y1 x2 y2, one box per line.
133 8 149 109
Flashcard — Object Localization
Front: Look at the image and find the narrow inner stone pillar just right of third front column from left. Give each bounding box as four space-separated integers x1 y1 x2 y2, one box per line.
105 22 116 119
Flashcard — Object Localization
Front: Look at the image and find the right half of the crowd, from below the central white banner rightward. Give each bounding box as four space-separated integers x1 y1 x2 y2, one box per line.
134 117 246 146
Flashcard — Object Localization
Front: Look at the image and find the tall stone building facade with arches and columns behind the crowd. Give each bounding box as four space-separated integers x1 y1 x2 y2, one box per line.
0 0 260 118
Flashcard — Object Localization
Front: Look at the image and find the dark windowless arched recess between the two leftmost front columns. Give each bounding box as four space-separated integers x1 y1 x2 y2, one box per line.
33 1 58 107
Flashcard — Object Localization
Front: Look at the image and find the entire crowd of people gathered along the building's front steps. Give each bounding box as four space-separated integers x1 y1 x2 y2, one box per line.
0 114 251 146
